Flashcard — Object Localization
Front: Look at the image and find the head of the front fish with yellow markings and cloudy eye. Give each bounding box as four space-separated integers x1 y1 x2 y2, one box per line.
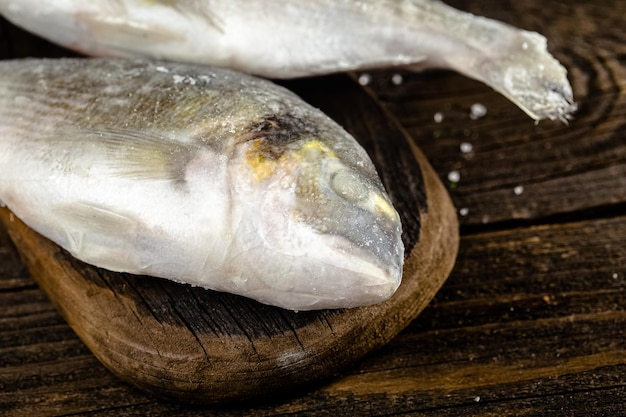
228 114 404 310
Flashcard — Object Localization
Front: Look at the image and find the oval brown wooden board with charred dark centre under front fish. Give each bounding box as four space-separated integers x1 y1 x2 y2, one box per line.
0 76 458 403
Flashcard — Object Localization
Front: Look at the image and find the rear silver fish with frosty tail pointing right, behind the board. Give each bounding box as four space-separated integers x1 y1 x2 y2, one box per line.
0 0 576 121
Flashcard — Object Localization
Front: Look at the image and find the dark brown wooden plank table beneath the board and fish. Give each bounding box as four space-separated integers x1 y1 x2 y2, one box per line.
0 0 626 416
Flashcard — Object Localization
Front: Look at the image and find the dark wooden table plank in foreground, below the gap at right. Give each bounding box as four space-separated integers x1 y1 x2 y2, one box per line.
0 217 626 415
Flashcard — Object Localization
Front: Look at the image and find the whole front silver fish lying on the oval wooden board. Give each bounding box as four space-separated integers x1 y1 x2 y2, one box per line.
0 58 404 310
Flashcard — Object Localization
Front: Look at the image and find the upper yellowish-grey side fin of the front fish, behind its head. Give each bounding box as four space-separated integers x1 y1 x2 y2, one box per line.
58 128 198 182
